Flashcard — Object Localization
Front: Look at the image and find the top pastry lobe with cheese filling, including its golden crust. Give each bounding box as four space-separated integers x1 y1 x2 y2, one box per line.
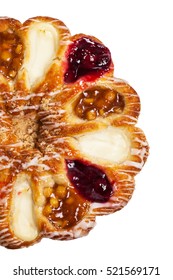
17 17 70 92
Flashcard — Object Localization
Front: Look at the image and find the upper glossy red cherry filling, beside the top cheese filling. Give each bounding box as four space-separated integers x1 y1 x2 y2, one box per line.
64 37 111 83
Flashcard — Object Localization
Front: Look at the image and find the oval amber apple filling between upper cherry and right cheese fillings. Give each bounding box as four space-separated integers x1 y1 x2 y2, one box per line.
74 87 125 121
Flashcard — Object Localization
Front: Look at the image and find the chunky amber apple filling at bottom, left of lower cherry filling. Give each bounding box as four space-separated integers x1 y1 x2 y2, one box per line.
43 184 88 229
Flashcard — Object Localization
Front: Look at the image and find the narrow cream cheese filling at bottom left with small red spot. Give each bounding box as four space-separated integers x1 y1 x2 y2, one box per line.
11 174 38 241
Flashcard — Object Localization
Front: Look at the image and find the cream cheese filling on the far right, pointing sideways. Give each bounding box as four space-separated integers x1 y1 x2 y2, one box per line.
78 127 130 164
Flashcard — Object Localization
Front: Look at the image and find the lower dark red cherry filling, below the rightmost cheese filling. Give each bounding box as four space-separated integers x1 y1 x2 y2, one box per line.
66 160 113 202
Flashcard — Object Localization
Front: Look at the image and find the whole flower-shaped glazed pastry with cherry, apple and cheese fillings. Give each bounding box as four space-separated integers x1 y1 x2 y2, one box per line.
0 17 149 249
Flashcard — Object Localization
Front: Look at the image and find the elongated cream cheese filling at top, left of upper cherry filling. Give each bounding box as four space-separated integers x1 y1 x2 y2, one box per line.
24 22 59 86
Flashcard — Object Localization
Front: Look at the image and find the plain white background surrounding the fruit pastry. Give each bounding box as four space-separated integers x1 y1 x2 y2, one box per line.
0 0 173 280
